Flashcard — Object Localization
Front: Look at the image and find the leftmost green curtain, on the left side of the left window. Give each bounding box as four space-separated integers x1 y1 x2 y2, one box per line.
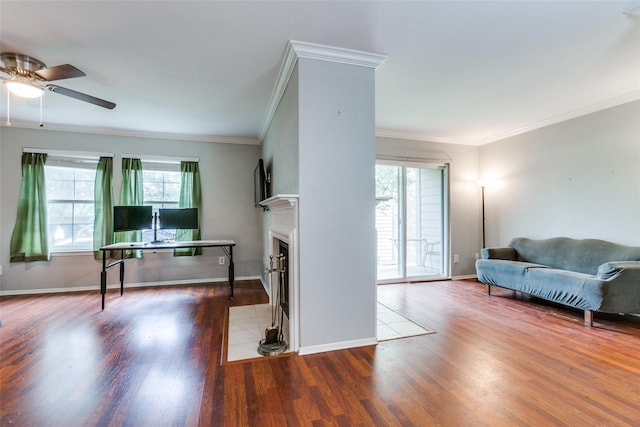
10 153 50 262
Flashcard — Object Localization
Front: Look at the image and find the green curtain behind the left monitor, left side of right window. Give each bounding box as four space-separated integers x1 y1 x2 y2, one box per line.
114 158 143 258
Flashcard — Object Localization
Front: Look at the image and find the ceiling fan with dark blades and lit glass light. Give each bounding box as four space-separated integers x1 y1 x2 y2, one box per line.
0 52 116 110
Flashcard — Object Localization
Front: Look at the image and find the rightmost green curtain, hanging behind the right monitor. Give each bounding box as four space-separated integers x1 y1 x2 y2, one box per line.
173 161 202 256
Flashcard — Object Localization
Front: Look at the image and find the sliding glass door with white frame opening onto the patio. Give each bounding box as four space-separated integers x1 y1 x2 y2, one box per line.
376 162 448 282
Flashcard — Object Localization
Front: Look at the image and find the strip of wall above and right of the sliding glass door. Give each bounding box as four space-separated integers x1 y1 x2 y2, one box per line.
376 137 482 277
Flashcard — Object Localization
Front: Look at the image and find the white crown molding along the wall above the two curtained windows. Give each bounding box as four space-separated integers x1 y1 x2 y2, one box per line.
0 121 261 145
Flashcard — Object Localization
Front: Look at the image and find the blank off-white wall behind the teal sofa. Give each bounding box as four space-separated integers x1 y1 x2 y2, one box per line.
480 101 640 246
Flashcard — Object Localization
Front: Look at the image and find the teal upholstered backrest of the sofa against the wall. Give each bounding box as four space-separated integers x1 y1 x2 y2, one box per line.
509 237 640 275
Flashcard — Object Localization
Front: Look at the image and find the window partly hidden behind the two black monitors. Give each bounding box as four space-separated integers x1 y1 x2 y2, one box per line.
142 161 181 242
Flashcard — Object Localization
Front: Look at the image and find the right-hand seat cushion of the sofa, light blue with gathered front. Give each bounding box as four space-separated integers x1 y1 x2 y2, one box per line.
520 268 606 310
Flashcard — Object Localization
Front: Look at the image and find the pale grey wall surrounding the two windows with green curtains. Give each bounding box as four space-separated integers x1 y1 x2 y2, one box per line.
0 128 262 293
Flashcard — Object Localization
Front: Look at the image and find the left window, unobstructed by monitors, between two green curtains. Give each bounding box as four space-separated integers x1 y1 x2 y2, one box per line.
45 156 97 252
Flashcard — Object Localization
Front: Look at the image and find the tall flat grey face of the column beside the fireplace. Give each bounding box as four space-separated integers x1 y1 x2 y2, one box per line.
298 58 376 352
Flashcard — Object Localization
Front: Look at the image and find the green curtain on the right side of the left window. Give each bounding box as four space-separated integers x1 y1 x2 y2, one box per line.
93 157 113 259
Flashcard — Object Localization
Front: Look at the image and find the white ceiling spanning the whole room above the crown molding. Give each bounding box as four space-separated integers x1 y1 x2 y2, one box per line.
0 0 640 145
